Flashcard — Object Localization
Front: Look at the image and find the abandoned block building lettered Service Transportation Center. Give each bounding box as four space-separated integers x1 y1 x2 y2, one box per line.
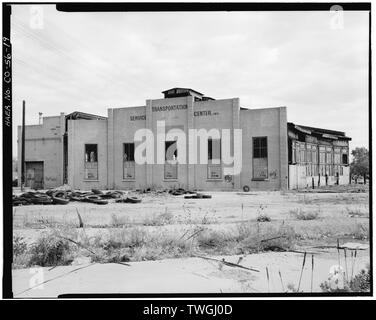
18 88 351 190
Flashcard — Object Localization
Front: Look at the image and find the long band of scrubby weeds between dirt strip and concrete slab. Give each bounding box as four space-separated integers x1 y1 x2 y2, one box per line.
15 216 296 266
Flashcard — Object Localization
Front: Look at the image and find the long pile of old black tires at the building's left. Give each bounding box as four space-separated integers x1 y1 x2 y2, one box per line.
13 189 141 206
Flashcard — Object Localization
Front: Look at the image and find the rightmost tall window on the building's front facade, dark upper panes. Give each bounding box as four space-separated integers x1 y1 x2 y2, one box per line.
253 137 268 180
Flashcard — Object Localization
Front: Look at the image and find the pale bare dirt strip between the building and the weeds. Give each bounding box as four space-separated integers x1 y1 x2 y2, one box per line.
13 192 369 229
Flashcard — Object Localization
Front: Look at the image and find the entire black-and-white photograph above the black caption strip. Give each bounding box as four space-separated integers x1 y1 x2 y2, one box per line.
2 2 373 302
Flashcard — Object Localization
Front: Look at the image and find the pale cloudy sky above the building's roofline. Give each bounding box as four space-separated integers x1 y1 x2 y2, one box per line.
11 5 369 156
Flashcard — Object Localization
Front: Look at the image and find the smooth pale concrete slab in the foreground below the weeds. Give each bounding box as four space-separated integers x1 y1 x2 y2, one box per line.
13 252 369 298
